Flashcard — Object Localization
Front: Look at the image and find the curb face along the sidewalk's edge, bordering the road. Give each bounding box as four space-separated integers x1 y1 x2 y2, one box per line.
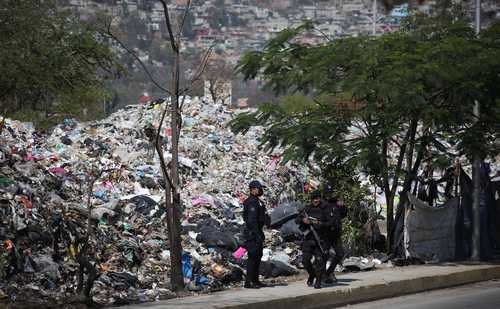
217 265 500 309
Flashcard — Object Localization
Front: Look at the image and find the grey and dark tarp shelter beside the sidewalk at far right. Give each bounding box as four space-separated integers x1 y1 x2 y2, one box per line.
391 165 500 262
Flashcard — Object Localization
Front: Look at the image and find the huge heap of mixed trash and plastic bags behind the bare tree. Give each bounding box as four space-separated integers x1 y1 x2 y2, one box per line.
0 98 308 305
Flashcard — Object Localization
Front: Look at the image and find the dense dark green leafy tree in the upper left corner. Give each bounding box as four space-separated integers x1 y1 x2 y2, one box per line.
0 0 121 124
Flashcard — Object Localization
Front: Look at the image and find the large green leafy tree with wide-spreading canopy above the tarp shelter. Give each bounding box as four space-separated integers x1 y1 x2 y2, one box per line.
232 10 500 251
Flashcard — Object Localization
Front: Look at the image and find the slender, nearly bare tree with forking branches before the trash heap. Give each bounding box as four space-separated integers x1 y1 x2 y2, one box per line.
101 0 212 291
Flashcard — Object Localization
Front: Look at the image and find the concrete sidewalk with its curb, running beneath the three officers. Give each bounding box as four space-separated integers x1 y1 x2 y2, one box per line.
120 264 500 309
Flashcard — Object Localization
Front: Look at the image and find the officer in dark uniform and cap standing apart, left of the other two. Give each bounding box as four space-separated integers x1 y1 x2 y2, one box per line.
243 180 270 289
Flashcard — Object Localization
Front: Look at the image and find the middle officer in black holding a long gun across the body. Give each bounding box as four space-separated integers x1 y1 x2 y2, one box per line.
296 190 334 289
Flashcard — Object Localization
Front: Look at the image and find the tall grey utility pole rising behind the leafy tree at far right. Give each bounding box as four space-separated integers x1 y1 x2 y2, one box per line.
471 0 481 261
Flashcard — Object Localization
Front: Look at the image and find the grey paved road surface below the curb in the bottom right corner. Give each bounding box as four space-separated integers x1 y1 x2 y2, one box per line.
341 280 500 309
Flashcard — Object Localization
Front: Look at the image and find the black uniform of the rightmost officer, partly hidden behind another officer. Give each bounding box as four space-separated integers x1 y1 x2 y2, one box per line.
326 202 347 277
